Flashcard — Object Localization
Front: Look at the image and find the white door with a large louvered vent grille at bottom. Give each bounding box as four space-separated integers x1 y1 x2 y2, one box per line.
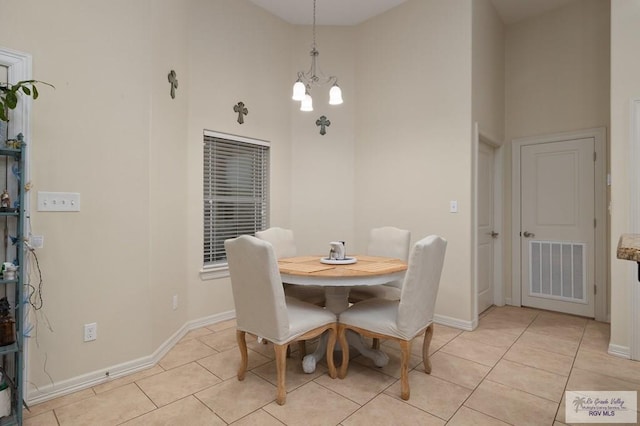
520 138 595 317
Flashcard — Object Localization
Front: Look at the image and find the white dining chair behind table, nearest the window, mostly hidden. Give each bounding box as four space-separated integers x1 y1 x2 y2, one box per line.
256 226 325 306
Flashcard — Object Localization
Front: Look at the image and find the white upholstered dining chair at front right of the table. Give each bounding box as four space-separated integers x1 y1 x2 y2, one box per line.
338 235 447 400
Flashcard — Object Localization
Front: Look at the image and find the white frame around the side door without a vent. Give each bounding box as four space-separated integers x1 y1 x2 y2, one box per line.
471 123 505 322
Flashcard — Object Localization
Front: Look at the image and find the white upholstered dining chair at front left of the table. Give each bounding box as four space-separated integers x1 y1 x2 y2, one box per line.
224 235 337 405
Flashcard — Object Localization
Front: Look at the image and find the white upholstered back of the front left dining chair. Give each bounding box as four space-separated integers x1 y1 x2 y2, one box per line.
224 235 289 341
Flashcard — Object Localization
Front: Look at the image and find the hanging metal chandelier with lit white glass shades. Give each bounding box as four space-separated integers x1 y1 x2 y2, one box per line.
291 0 342 111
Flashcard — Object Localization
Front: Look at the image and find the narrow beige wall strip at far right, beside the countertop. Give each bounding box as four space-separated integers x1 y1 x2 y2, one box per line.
610 0 640 348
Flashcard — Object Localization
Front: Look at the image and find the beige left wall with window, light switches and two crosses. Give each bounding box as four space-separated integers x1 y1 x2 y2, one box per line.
0 0 293 398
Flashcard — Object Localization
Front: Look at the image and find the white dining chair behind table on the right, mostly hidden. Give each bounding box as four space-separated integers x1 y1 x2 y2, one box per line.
349 226 411 303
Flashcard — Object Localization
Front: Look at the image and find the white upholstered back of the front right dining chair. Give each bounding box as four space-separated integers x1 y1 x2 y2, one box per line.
397 235 447 338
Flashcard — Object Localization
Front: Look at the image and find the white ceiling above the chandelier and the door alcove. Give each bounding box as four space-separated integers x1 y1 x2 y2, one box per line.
251 0 574 25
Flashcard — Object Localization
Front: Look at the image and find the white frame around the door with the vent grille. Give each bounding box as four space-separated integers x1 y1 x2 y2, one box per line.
511 127 609 322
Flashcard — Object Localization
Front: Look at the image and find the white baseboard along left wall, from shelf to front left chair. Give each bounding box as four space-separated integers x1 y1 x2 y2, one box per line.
25 311 235 405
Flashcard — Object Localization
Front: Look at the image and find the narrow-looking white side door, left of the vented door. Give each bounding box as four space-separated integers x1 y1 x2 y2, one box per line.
477 142 498 313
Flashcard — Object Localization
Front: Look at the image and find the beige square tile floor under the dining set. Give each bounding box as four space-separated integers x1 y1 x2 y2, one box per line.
25 307 640 426
